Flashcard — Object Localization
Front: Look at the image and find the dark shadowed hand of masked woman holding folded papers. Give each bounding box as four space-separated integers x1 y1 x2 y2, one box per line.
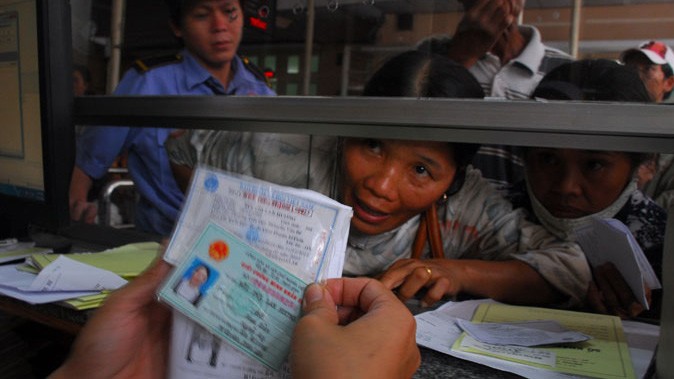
587 262 651 319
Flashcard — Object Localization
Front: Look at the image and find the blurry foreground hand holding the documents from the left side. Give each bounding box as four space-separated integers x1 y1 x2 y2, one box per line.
50 258 171 379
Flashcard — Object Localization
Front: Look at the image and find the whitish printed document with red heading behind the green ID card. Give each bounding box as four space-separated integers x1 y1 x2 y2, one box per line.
164 166 353 282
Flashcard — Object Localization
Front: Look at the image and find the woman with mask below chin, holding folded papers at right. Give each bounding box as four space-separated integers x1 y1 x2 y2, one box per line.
512 60 667 317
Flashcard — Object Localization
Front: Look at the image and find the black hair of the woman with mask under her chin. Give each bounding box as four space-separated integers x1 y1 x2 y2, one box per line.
532 59 654 169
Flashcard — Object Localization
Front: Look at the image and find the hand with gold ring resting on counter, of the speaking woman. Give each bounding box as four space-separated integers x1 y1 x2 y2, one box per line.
379 259 461 306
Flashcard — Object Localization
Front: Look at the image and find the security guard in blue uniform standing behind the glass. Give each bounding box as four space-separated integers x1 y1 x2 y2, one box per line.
70 0 274 235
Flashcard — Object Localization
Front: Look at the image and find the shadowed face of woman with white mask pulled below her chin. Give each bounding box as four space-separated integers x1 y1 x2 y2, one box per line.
526 148 632 218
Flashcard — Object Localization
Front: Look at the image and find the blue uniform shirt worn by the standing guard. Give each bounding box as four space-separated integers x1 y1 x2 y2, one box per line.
75 51 275 235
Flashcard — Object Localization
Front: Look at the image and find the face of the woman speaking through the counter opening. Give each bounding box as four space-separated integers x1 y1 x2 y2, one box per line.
342 138 456 235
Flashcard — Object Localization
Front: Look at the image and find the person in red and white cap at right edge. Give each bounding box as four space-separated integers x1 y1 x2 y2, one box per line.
620 41 674 103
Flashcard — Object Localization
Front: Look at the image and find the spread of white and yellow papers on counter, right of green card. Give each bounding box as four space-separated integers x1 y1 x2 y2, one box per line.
415 300 659 379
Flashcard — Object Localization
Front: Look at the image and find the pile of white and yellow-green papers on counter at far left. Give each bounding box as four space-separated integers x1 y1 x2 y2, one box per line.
0 242 159 310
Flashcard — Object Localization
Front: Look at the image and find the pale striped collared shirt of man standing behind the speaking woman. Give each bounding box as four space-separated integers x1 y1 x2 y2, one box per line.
469 25 573 195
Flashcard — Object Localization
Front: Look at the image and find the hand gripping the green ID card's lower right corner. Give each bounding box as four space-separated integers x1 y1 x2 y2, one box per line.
290 278 421 378
